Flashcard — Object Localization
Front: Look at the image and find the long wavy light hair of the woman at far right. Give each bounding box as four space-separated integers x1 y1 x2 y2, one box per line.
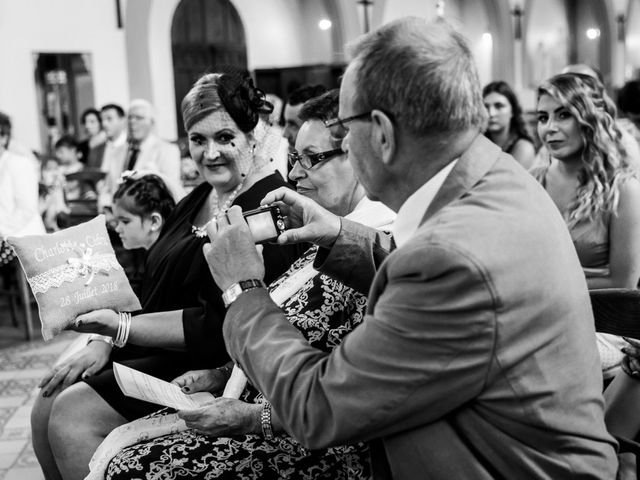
538 73 635 228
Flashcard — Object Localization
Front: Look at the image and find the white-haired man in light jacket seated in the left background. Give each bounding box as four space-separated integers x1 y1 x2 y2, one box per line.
125 99 180 184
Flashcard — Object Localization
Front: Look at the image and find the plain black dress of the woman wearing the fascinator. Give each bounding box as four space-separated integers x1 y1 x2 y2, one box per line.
85 173 300 421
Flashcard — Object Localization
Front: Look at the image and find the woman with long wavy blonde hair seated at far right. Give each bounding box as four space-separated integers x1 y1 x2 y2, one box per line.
532 73 640 376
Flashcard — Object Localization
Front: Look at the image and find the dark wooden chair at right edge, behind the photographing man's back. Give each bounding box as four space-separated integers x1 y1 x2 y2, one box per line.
589 288 640 478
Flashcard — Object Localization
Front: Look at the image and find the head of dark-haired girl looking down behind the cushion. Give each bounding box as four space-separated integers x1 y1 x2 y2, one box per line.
113 173 176 250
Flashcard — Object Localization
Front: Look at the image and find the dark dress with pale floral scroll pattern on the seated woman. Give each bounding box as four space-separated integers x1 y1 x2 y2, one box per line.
107 247 371 480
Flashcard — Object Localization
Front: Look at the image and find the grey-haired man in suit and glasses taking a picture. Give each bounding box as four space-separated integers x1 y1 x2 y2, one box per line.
205 18 617 479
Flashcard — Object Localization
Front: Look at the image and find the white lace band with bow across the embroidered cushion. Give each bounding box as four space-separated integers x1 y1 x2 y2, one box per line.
27 248 122 295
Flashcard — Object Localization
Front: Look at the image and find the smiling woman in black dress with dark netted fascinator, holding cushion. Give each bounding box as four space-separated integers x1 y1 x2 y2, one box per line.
31 74 299 480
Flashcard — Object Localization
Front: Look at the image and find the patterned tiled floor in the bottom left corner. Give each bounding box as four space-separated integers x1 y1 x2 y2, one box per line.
0 318 74 480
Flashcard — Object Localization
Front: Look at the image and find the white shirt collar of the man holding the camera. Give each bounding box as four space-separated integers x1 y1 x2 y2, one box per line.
393 158 458 247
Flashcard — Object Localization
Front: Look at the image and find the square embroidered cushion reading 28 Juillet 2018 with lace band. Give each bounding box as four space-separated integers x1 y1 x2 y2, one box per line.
7 215 141 340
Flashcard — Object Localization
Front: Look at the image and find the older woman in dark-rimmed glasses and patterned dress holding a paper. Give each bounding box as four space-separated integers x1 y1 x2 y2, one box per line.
91 90 395 480
